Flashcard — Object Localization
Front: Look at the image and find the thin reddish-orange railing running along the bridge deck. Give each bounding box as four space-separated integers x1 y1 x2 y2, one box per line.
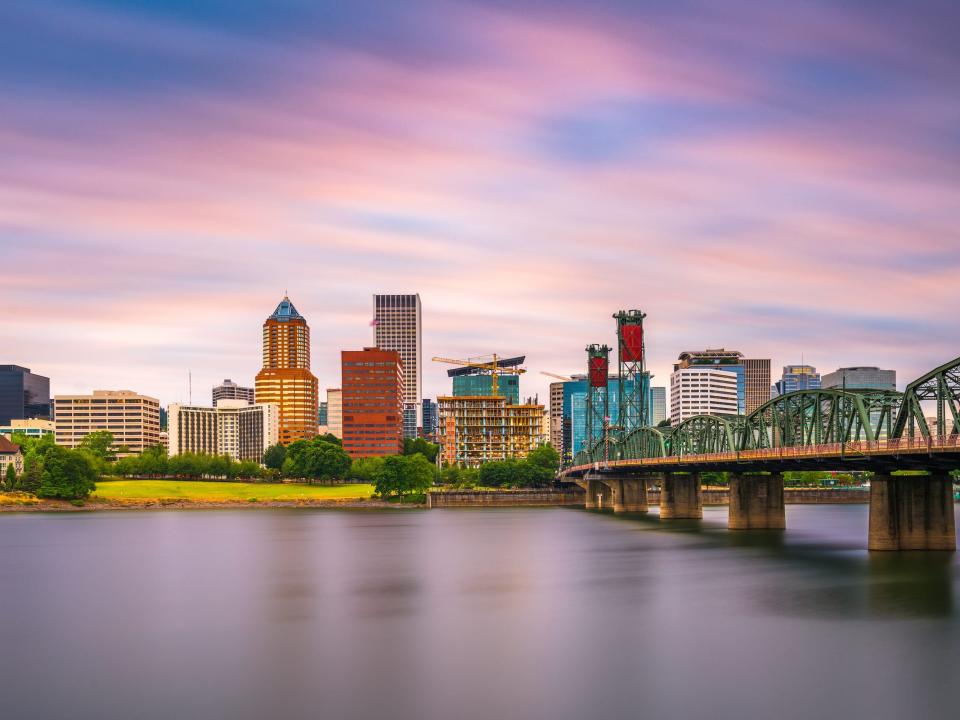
570 433 960 470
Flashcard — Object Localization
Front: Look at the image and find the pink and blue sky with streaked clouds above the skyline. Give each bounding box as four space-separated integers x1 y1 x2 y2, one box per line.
0 0 960 403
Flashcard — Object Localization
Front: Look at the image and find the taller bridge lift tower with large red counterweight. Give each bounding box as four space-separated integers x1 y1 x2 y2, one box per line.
613 310 650 438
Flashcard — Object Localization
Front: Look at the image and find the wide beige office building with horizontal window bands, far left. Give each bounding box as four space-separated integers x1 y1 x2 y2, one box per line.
53 390 160 453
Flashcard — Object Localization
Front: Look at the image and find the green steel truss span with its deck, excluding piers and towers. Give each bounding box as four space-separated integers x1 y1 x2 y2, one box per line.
561 358 960 479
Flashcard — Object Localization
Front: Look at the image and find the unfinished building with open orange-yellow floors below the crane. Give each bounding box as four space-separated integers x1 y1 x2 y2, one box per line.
437 395 546 467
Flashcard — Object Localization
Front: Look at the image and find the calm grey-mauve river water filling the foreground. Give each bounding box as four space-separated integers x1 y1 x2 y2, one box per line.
0 506 960 719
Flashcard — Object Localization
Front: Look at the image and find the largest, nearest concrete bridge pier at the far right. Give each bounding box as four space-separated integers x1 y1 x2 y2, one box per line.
867 473 957 550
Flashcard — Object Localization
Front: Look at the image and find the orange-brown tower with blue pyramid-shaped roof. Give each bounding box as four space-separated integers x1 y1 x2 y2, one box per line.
255 297 319 445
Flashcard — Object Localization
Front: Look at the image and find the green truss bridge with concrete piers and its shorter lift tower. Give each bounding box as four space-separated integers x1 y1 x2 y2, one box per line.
560 352 960 551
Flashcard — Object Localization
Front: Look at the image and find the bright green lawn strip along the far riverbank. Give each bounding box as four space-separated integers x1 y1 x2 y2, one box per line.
93 480 373 502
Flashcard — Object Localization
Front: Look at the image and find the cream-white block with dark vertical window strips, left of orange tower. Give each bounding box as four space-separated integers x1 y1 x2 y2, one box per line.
167 399 280 463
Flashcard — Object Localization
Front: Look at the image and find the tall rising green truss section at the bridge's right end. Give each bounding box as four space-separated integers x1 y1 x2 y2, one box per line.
892 358 960 438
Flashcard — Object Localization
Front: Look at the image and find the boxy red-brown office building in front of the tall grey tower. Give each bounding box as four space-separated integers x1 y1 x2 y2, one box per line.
340 348 404 458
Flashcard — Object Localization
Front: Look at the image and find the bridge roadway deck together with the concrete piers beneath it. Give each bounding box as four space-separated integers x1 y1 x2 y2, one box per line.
561 433 960 550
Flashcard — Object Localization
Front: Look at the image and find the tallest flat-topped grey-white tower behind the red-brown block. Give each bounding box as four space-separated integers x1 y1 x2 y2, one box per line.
371 295 423 438
